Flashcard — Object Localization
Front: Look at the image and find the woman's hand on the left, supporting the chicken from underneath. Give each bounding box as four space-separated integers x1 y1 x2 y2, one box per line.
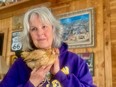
29 65 52 87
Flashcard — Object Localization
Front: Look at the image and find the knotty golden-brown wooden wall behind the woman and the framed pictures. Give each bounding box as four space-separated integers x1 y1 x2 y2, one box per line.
0 0 116 87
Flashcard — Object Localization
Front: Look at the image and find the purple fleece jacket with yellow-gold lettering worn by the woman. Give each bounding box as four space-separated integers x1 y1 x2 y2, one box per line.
0 43 96 87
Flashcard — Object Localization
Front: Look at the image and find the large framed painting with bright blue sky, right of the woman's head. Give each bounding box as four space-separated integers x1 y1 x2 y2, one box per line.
58 8 94 48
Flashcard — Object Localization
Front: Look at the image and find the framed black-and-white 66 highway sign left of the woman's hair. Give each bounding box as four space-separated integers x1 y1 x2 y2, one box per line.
11 31 22 52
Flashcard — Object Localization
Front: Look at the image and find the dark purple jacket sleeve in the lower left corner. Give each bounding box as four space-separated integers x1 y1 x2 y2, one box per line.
0 60 34 87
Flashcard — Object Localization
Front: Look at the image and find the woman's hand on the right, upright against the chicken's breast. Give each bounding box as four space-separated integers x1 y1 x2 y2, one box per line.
50 58 60 75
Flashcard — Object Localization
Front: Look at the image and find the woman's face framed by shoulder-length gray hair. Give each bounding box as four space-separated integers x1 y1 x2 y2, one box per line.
29 15 53 49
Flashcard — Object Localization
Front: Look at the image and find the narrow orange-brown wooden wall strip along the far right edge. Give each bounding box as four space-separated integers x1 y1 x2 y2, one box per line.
109 0 116 87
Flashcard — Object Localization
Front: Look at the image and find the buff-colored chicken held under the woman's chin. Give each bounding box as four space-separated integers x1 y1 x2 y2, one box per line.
21 48 59 69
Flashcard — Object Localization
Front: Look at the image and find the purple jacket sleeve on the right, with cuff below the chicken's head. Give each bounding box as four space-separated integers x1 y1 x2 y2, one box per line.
54 60 96 87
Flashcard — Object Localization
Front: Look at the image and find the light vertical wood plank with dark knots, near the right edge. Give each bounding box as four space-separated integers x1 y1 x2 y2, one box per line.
104 0 112 87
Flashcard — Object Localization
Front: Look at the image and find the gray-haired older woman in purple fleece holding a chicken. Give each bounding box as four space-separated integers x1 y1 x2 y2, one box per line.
0 7 95 87
